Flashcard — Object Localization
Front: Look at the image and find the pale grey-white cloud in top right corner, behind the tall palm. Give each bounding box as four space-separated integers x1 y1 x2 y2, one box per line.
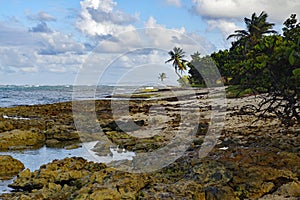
191 0 300 40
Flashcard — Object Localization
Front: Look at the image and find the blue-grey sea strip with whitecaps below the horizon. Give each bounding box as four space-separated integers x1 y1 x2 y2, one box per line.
0 85 135 107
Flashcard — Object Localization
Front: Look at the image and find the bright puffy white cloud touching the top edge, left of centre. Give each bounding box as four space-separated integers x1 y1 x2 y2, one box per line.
77 0 137 37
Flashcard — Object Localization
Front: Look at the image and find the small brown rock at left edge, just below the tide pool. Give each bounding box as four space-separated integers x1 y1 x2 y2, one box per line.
0 155 24 180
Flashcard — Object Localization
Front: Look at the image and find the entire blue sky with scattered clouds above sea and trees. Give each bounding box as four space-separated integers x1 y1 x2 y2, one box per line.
0 0 300 85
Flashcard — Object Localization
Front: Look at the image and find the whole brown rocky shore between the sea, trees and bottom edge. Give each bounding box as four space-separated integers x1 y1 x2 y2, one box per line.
0 88 300 200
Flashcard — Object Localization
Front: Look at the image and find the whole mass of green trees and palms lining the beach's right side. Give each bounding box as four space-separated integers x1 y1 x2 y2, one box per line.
167 12 300 126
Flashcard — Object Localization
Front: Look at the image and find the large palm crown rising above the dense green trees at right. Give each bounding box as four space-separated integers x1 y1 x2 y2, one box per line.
227 11 277 49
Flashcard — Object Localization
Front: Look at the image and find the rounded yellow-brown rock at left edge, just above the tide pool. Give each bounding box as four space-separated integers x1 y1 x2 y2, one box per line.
0 129 45 150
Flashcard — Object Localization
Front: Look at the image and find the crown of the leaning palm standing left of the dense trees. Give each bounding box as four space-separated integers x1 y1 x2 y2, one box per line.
165 47 188 80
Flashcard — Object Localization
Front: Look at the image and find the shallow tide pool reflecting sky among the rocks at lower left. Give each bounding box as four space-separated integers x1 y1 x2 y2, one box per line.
0 141 135 194
